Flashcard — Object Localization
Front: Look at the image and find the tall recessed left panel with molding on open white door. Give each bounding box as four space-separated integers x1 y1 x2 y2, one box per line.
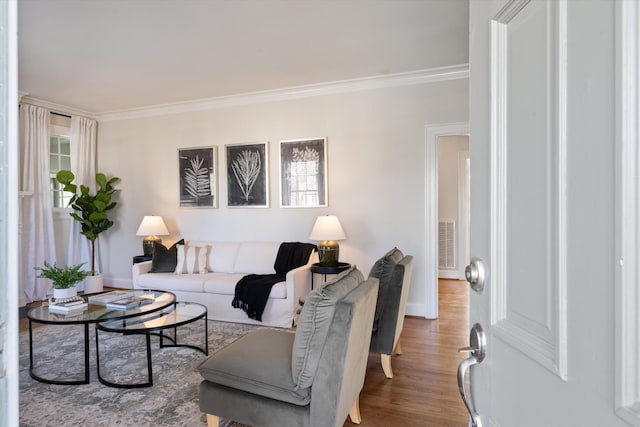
490 1 566 378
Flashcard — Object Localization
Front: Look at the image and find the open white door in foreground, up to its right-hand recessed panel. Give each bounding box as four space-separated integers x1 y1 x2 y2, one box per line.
464 0 627 427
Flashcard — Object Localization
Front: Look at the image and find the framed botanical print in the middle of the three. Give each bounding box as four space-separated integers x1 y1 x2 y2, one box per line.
225 142 269 208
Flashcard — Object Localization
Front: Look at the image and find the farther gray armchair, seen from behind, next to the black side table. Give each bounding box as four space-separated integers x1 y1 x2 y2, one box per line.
369 248 413 378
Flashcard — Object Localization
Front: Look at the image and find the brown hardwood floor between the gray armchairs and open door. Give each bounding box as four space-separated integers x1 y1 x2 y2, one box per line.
344 280 469 427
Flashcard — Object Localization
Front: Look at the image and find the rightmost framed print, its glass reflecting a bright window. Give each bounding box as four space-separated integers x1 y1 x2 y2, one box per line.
280 138 327 207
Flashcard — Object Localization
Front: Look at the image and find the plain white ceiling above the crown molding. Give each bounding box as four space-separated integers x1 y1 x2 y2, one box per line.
18 0 469 114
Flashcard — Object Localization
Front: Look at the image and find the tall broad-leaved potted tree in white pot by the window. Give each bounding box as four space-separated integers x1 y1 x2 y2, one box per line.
56 170 120 292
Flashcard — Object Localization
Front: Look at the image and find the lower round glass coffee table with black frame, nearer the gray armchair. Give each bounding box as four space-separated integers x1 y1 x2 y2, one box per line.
96 302 209 388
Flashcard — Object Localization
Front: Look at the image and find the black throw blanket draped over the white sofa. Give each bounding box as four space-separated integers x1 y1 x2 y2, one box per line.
231 242 316 322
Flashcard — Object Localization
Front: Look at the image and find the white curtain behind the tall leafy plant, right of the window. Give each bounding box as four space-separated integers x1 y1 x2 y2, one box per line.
67 116 101 290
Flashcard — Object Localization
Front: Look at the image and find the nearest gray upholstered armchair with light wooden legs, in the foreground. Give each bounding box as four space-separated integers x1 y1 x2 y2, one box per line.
200 268 378 427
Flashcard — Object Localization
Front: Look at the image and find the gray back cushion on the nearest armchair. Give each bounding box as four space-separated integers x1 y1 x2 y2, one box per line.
291 266 364 388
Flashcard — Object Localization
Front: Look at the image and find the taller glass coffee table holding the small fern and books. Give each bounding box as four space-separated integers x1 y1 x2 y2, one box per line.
27 290 176 385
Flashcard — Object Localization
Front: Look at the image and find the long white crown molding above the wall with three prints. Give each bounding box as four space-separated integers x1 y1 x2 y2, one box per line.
95 64 469 122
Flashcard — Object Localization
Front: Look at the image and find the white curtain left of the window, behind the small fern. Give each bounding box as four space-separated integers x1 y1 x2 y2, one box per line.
19 104 56 302
